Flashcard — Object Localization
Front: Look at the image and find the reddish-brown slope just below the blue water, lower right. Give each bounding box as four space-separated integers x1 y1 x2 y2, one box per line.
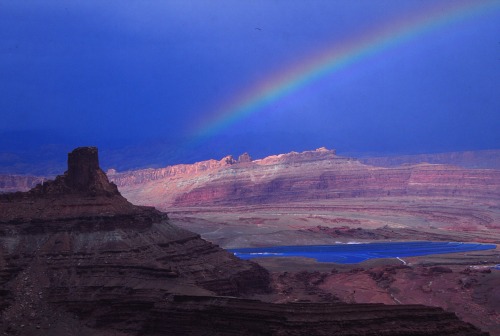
267 264 500 335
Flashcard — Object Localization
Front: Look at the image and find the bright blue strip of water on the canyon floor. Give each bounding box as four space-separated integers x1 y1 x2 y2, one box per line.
229 241 496 264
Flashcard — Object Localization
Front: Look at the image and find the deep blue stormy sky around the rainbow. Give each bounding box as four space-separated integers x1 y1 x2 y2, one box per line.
0 0 500 172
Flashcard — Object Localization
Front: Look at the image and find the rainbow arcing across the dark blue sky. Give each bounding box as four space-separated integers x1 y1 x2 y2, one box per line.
192 0 500 138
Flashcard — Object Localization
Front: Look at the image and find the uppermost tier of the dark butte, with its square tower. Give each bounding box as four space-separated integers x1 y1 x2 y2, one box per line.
0 147 167 233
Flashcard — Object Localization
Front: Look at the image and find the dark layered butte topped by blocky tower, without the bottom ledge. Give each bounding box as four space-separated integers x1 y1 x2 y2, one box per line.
0 147 269 334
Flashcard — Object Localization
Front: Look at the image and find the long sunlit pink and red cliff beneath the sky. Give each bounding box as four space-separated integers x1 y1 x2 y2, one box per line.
104 148 500 209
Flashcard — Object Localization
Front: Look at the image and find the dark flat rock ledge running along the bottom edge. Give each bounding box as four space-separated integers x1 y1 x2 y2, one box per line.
142 296 487 336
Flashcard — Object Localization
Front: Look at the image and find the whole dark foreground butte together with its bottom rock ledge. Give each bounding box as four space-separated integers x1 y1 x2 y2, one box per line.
0 147 486 335
